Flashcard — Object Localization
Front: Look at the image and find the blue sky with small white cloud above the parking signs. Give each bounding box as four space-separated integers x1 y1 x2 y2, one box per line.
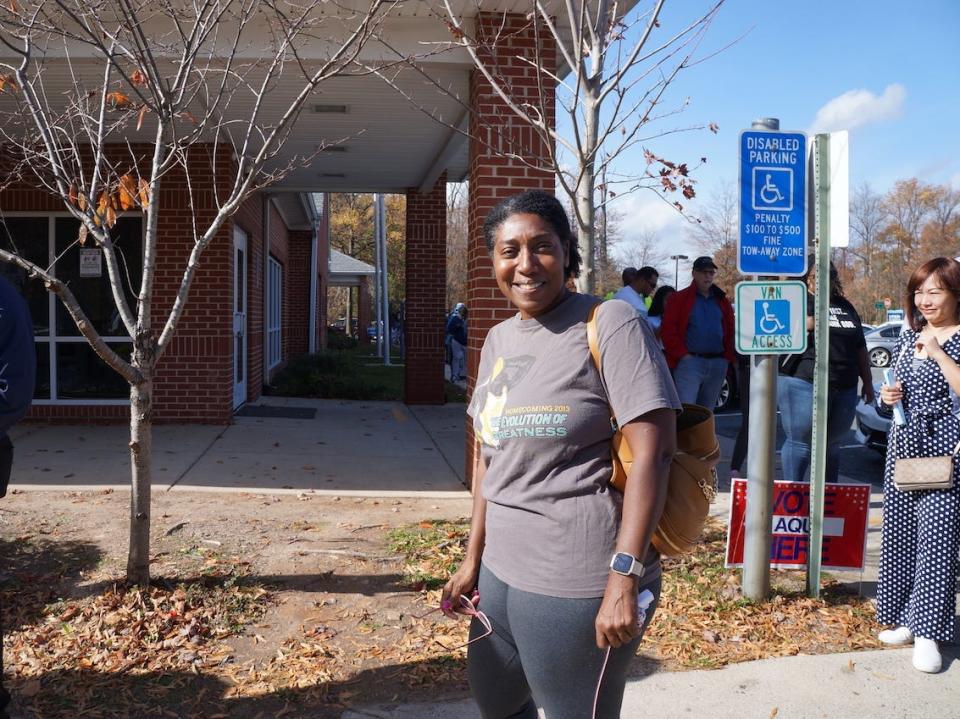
604 0 960 274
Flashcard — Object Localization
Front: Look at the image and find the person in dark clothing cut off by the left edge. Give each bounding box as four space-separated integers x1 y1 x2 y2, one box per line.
0 275 37 717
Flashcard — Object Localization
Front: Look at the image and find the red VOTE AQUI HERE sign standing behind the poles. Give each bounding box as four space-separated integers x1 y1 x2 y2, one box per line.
726 479 870 571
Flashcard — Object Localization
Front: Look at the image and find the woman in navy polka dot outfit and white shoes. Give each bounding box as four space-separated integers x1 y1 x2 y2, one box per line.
877 257 960 673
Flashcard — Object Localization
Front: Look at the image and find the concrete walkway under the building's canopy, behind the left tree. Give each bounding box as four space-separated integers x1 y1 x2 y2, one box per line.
11 397 468 497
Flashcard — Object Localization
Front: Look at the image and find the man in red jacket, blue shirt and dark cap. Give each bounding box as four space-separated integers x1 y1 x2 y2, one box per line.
660 257 736 409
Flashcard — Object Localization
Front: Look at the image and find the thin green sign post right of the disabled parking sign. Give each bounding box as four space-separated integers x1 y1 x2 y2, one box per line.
807 134 830 598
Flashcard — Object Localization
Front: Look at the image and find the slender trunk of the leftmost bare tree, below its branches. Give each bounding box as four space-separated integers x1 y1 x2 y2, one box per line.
127 367 153 587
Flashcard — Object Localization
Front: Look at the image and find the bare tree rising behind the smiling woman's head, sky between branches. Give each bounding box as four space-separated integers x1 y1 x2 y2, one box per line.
444 0 723 293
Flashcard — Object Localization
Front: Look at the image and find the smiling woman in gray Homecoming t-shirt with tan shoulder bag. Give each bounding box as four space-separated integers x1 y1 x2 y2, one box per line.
441 192 680 719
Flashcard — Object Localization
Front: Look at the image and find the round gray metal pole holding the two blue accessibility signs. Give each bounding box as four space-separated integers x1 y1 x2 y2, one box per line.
741 117 780 600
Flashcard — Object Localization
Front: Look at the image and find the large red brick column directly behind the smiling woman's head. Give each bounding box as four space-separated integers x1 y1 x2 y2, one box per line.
465 13 556 486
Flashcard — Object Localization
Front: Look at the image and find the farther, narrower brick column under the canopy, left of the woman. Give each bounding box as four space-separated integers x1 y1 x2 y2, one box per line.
403 173 447 404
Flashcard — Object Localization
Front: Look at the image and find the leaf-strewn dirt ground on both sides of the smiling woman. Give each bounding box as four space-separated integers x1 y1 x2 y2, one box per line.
2 510 876 719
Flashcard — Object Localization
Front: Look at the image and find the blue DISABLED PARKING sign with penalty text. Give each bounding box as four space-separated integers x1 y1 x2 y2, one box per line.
737 130 807 276
